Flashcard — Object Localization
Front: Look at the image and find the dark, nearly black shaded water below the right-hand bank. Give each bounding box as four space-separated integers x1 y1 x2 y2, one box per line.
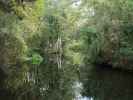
79 68 133 100
